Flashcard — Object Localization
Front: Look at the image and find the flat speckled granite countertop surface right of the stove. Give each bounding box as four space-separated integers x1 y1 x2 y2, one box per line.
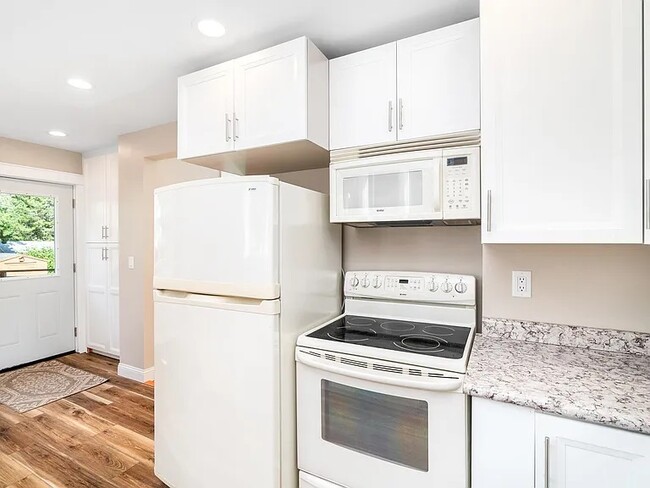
463 334 650 434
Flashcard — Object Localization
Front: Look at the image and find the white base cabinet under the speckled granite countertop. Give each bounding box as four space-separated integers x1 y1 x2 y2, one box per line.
472 398 650 488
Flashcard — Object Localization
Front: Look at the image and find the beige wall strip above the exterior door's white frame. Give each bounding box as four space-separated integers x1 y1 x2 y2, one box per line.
0 137 82 174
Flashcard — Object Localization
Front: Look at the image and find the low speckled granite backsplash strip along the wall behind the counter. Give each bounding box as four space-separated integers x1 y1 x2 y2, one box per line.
483 317 650 356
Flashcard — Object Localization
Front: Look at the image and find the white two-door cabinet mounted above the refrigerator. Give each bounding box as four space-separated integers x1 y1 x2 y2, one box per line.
178 37 329 174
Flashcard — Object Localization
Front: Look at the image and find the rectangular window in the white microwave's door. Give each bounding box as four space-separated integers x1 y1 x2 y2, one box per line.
343 170 422 209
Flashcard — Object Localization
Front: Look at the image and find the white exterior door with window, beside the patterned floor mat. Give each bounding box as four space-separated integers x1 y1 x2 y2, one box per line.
0 178 75 369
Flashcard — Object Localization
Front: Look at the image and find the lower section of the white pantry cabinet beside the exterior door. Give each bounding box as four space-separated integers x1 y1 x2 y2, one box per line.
86 243 120 356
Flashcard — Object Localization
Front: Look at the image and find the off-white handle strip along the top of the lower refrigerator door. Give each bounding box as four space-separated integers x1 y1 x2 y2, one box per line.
153 290 280 315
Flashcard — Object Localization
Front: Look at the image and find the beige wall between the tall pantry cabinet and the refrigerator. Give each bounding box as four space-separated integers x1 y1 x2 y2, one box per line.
118 123 219 369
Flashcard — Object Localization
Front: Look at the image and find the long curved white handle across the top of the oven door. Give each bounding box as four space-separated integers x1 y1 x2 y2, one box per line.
296 349 463 391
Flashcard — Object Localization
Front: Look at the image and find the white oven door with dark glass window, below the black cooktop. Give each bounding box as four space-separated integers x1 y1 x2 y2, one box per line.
296 351 469 488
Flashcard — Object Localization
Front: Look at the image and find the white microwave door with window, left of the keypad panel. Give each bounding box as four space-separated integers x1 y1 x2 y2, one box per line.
330 150 442 223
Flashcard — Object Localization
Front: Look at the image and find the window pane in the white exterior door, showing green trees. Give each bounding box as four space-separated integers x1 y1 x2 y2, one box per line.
0 193 56 278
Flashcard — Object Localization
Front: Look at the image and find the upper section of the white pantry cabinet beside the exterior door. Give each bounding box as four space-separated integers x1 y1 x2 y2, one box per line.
83 153 119 242
